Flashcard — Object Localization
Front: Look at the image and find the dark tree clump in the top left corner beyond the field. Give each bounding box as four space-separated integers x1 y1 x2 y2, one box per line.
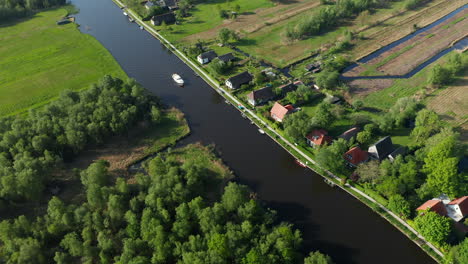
0 0 66 23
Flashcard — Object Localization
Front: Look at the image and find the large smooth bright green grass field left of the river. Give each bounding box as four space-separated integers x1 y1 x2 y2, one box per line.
0 8 126 116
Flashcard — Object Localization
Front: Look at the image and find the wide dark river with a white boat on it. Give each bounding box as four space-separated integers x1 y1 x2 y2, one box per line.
72 0 435 264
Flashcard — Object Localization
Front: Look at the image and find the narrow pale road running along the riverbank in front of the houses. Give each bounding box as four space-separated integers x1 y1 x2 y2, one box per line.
114 0 444 257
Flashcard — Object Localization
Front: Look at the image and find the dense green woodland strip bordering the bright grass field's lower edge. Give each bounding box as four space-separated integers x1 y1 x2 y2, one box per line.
0 76 160 203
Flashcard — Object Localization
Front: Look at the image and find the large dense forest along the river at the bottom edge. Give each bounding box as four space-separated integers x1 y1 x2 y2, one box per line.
0 146 332 264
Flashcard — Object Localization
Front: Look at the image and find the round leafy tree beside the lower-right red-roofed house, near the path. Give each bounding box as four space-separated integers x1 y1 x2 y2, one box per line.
414 211 452 245
